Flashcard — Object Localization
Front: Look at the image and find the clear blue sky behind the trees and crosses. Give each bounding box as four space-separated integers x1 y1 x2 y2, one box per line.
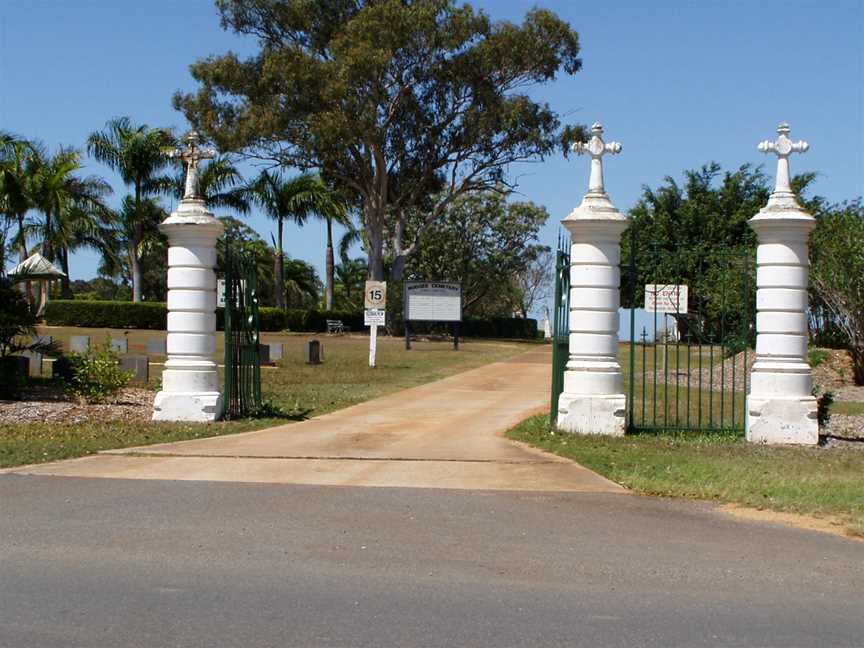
0 0 864 288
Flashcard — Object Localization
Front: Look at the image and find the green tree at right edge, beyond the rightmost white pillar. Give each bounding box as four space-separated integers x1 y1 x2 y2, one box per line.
810 198 864 385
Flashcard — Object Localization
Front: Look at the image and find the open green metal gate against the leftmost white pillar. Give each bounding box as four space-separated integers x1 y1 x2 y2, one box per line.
223 242 261 419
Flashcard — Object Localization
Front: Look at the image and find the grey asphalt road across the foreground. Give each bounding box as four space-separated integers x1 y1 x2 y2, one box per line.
0 475 864 648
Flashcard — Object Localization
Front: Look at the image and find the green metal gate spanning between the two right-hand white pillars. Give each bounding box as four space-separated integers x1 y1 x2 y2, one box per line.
622 230 756 433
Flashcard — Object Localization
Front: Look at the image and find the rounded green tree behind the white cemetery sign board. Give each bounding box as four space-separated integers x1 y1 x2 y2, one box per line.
406 191 549 315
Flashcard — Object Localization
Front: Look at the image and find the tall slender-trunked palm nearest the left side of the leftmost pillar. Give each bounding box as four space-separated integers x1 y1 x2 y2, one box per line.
87 117 176 302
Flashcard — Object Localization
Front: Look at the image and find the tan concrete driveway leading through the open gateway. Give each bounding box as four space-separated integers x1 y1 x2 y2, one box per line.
3 347 624 493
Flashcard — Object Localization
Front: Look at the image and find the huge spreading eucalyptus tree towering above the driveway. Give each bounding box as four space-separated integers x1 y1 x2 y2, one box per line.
174 0 583 280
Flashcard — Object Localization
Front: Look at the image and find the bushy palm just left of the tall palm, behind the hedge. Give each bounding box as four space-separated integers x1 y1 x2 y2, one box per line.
32 148 111 298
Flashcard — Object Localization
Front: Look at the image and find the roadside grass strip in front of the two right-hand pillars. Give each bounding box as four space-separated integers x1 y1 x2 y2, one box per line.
508 416 864 535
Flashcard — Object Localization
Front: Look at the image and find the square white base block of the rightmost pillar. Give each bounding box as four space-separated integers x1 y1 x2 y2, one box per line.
747 396 819 445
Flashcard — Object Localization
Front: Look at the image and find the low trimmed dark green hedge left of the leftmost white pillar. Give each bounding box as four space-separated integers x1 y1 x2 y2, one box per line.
45 299 168 331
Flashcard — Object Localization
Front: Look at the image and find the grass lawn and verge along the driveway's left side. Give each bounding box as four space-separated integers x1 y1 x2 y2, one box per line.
0 334 531 468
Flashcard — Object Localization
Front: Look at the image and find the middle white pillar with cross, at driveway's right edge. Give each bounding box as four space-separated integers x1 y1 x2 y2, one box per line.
558 124 627 436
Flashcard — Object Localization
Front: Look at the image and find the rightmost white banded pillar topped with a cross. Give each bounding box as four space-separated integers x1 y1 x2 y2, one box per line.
747 124 819 445
